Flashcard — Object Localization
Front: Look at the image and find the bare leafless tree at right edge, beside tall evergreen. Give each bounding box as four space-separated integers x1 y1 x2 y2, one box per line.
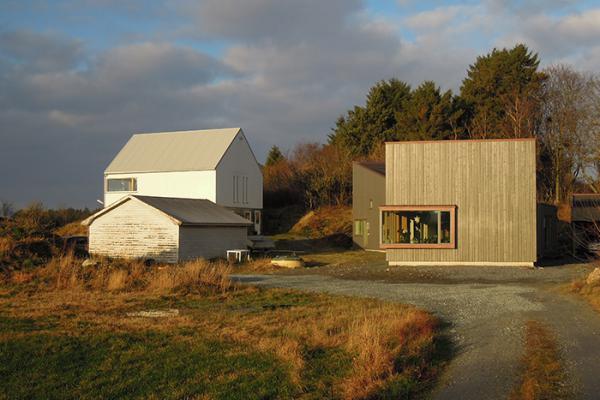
540 65 600 204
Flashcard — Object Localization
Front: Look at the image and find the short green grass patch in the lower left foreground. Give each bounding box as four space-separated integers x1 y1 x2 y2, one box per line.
0 333 293 399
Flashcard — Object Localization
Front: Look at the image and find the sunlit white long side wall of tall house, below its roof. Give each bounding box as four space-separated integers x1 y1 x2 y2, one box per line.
104 171 217 207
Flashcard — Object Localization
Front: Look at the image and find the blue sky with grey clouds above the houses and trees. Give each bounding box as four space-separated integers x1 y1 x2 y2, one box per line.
0 0 600 208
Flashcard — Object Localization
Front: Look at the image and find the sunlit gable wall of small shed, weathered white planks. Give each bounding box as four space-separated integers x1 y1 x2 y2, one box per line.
89 200 179 263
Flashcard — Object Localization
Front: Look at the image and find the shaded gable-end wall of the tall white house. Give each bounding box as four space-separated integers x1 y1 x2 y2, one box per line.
216 131 263 208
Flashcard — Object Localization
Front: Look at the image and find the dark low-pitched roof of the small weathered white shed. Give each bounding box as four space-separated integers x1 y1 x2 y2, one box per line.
82 195 252 226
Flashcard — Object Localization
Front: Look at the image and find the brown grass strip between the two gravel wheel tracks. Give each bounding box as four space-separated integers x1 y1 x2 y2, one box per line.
510 321 572 400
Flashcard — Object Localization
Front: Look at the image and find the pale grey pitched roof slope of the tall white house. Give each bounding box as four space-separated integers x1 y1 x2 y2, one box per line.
104 128 241 174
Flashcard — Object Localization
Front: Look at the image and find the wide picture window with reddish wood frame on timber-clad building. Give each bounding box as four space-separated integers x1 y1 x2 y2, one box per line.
380 206 456 249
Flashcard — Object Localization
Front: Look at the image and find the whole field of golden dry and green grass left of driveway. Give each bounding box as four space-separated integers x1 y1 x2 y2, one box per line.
0 257 443 399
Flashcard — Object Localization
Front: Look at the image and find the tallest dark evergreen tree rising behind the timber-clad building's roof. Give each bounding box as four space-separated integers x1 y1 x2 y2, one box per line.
460 44 545 138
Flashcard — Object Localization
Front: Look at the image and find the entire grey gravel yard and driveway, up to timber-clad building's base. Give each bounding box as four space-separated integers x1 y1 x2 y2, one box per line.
235 253 600 399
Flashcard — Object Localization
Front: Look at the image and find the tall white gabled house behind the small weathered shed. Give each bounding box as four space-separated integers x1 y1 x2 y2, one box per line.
104 128 263 234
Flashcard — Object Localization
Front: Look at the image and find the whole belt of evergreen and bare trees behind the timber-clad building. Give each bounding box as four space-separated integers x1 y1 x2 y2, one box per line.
263 44 600 209
